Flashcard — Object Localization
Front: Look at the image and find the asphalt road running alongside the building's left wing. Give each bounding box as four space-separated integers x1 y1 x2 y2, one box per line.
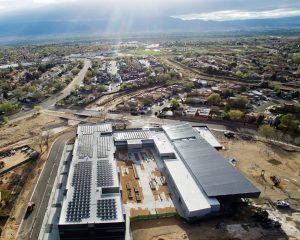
16 132 75 240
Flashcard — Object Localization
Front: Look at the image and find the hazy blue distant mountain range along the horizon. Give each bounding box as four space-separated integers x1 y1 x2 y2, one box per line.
0 17 300 39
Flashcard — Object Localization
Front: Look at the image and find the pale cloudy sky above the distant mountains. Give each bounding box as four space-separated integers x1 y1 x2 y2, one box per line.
0 0 300 21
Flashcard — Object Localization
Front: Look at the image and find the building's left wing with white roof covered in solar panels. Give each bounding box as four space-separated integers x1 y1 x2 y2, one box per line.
58 124 125 240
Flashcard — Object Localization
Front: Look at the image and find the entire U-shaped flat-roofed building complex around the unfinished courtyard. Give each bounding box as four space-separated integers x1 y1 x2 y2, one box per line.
59 123 260 239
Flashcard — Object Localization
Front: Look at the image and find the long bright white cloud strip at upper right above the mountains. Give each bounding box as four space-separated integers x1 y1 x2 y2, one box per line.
172 8 300 21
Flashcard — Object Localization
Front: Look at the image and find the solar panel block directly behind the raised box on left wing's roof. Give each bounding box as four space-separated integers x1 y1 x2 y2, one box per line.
97 159 114 187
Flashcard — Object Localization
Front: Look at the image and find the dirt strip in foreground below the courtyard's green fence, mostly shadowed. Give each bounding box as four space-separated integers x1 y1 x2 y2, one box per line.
131 218 284 240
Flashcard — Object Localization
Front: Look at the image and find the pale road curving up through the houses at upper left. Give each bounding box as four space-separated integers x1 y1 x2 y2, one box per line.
10 60 91 122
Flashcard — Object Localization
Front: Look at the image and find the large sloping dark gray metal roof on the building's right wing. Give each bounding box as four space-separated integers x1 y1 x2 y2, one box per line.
174 139 260 197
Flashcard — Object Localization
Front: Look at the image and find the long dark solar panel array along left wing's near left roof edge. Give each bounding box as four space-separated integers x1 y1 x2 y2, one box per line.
66 162 92 222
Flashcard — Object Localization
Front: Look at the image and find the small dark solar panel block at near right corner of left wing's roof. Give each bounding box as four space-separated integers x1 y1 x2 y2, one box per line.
97 199 117 221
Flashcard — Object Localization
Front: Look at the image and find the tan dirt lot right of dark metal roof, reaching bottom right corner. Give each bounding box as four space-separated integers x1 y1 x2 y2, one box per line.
217 133 300 239
